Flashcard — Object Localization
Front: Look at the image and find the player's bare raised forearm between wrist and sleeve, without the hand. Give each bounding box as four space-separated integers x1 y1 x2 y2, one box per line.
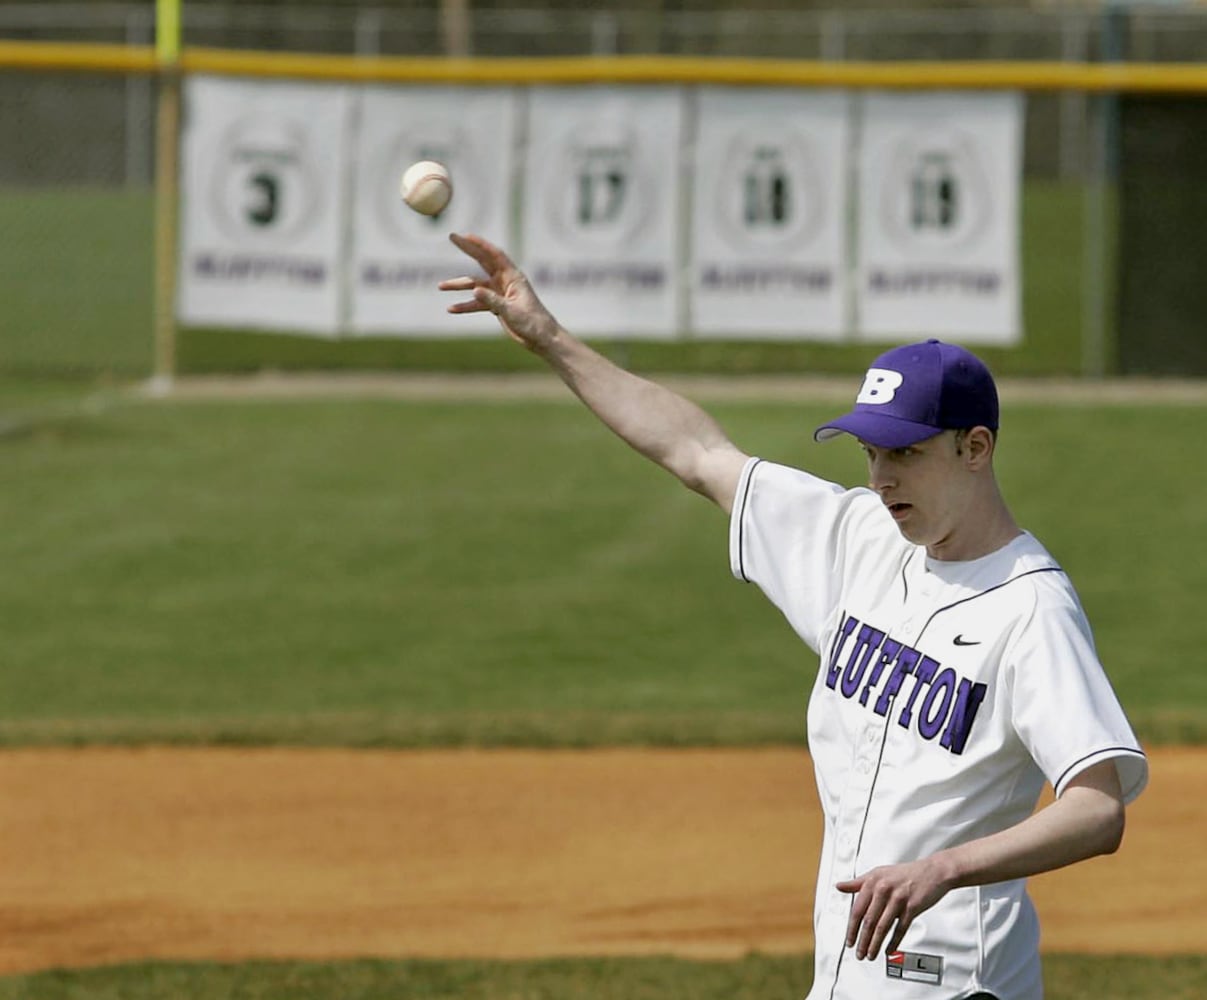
536 328 736 496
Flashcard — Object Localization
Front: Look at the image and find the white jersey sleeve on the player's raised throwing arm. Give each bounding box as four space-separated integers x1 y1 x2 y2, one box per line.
729 458 891 650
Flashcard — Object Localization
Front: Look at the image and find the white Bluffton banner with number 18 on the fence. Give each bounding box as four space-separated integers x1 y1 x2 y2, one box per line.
690 87 851 340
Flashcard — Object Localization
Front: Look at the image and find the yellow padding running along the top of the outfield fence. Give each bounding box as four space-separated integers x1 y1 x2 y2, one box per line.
0 41 1207 93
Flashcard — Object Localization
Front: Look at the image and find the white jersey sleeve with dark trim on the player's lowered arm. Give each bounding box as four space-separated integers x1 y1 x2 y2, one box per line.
1008 586 1148 802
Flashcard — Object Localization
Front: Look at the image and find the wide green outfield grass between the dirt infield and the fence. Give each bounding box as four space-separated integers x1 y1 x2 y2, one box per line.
0 386 1207 745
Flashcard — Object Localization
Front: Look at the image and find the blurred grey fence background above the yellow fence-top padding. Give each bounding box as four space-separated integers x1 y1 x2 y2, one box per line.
9 0 1207 62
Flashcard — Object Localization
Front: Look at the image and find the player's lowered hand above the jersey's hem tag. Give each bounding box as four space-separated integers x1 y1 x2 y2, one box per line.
835 858 951 959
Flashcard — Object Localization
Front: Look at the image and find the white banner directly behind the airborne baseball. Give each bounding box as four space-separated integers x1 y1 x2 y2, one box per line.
350 87 518 337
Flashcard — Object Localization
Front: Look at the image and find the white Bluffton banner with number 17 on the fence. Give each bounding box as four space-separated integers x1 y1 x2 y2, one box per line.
523 86 683 338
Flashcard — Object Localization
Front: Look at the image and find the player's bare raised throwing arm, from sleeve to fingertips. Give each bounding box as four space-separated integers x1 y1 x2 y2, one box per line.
439 234 747 514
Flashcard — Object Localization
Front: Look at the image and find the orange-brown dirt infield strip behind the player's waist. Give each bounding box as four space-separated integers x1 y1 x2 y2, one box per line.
0 749 1207 973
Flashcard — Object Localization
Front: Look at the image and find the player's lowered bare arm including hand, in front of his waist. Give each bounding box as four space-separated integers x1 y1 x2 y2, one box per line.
836 760 1124 959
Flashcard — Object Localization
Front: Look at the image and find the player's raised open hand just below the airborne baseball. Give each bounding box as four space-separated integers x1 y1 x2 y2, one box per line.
439 233 559 352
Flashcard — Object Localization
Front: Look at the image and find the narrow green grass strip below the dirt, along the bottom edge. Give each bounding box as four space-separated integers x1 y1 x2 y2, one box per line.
0 955 1207 1000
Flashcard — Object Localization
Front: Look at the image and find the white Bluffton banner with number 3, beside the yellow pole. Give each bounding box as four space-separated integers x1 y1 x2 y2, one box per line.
177 77 350 335
